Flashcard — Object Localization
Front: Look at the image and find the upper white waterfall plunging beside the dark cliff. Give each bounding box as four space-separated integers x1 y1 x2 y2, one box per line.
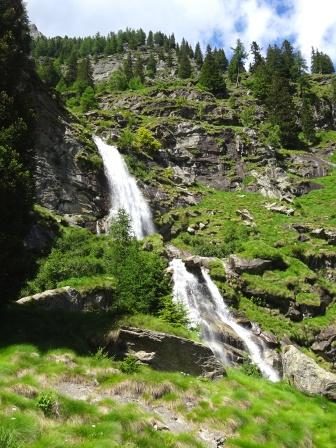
93 137 154 239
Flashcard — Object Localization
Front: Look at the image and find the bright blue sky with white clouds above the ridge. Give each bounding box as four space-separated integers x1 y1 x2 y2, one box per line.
25 0 336 64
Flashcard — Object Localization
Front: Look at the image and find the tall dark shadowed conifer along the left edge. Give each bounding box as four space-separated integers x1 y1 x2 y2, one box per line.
0 0 33 302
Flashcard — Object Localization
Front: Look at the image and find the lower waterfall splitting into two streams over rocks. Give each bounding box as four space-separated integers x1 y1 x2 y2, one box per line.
170 259 279 381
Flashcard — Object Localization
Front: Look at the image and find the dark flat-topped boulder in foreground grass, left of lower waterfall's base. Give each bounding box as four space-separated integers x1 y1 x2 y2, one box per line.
107 327 225 376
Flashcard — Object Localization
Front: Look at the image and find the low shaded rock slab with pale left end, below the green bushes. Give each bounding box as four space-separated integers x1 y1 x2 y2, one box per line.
16 286 113 311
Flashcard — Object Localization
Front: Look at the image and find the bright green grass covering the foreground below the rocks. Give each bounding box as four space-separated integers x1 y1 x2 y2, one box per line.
0 345 336 448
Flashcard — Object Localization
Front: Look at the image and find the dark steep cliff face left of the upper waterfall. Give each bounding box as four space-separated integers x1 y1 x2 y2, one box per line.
34 81 108 224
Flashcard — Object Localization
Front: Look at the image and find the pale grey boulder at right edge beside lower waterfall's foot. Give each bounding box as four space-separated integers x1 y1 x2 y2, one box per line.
282 345 336 401
